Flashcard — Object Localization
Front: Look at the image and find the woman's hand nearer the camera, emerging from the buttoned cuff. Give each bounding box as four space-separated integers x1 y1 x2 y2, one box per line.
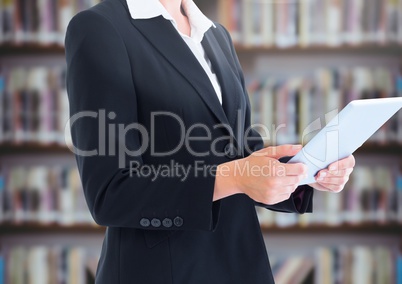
214 145 307 205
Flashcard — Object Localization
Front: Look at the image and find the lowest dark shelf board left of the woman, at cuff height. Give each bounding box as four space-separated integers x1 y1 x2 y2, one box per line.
0 223 105 235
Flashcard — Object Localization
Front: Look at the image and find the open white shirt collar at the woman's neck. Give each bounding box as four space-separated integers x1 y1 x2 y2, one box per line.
126 0 216 42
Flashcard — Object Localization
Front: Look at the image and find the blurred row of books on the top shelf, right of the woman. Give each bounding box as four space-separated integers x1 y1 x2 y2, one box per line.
218 0 402 48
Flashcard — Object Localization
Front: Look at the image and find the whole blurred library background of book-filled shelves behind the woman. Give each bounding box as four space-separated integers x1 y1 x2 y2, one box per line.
0 0 402 284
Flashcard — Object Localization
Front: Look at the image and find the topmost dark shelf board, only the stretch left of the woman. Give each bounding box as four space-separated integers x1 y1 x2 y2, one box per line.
0 43 64 57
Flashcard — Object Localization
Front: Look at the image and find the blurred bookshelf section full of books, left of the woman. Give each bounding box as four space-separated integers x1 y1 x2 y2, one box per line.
0 0 105 284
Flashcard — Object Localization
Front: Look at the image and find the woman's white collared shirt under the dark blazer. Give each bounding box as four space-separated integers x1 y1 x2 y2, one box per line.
126 0 222 104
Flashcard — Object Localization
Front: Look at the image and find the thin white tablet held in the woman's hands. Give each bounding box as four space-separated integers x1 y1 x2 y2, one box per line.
288 97 402 185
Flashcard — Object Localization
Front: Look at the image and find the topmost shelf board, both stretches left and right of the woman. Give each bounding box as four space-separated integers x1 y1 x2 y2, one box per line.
0 43 402 56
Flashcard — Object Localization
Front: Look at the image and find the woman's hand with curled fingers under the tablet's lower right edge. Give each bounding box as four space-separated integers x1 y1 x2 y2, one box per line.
309 155 355 192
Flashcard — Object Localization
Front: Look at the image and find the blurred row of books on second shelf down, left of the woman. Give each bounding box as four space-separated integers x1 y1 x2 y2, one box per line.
0 66 72 145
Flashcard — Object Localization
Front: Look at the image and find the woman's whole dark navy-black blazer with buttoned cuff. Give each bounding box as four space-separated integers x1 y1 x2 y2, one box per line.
65 0 313 284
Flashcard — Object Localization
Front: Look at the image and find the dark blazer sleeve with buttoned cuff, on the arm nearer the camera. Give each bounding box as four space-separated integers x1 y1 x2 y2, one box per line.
65 10 220 231
